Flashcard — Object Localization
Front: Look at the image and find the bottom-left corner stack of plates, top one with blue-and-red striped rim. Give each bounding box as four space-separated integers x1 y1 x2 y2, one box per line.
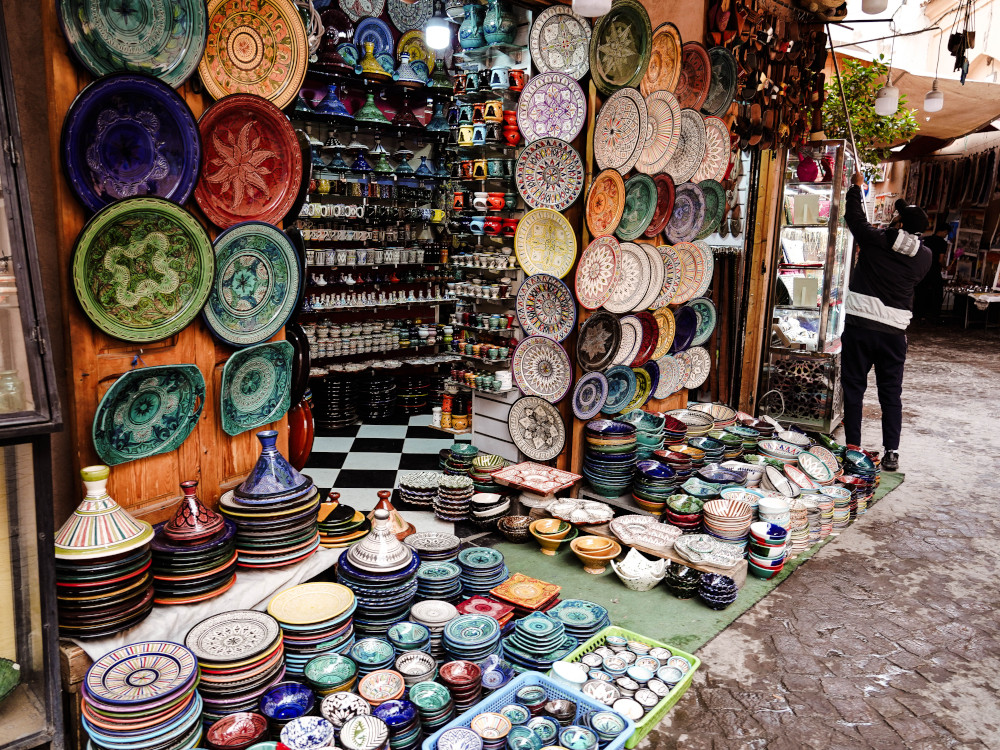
81 641 202 750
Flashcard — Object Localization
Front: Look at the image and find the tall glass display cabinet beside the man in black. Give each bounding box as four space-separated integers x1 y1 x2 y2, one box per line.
761 140 855 432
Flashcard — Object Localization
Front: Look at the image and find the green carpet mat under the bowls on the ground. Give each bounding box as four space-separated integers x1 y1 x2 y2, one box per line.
492 473 904 653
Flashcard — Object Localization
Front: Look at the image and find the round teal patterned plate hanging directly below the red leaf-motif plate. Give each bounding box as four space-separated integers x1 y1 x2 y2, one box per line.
204 221 302 346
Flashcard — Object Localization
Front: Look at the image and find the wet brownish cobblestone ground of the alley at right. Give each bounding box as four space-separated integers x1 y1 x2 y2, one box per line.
641 327 1000 750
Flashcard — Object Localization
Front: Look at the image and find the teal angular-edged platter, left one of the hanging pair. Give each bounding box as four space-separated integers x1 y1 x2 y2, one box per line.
91 365 205 466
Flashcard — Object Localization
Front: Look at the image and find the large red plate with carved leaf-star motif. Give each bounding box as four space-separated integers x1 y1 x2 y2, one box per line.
194 94 303 229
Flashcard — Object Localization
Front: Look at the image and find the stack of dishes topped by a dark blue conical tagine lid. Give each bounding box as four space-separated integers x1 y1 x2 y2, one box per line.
219 430 320 569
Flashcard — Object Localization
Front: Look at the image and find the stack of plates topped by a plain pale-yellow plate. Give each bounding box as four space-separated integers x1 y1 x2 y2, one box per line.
267 583 357 679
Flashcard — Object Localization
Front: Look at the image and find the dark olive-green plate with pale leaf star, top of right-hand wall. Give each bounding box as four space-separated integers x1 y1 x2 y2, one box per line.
590 0 653 96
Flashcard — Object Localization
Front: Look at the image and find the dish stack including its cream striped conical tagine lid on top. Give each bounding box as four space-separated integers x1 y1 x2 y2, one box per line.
55 466 153 638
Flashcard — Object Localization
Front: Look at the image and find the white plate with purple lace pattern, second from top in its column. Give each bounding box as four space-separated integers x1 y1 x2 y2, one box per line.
517 73 587 144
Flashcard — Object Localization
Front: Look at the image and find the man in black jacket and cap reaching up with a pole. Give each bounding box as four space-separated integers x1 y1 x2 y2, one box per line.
841 172 932 471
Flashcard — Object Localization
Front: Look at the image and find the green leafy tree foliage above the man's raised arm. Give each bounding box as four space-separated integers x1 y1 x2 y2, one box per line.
823 55 917 164
